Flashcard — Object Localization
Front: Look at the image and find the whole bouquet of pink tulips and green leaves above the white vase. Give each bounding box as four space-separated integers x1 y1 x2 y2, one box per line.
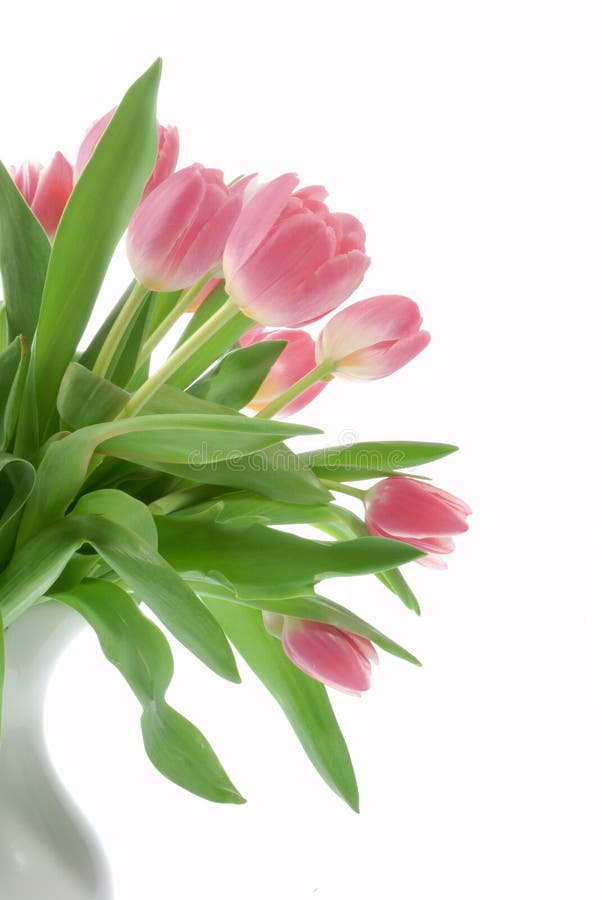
0 62 470 809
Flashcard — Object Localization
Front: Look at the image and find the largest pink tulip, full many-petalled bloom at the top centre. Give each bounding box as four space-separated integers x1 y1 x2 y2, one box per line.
223 174 370 327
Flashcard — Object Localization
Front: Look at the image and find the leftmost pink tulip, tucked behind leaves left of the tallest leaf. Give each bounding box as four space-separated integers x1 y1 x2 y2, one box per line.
12 153 73 240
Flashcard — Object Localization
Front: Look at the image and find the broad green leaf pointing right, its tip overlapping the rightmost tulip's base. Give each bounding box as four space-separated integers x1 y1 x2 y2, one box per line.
156 517 423 598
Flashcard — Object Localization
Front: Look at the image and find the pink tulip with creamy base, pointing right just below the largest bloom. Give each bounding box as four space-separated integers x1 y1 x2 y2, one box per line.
316 295 431 380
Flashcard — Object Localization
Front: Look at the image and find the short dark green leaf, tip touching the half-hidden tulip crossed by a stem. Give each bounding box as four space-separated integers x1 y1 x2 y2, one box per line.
190 341 287 409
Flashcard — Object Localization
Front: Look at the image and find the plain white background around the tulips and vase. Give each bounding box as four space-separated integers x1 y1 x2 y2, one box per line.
0 0 602 900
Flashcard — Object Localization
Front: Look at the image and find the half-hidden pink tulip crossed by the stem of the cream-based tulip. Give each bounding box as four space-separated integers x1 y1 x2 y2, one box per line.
240 326 328 417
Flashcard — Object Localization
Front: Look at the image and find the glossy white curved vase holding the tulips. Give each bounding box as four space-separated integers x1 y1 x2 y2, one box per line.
0 601 112 900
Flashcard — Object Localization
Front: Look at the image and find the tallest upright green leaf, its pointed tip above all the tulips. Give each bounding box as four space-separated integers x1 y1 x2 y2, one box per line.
35 61 161 435
